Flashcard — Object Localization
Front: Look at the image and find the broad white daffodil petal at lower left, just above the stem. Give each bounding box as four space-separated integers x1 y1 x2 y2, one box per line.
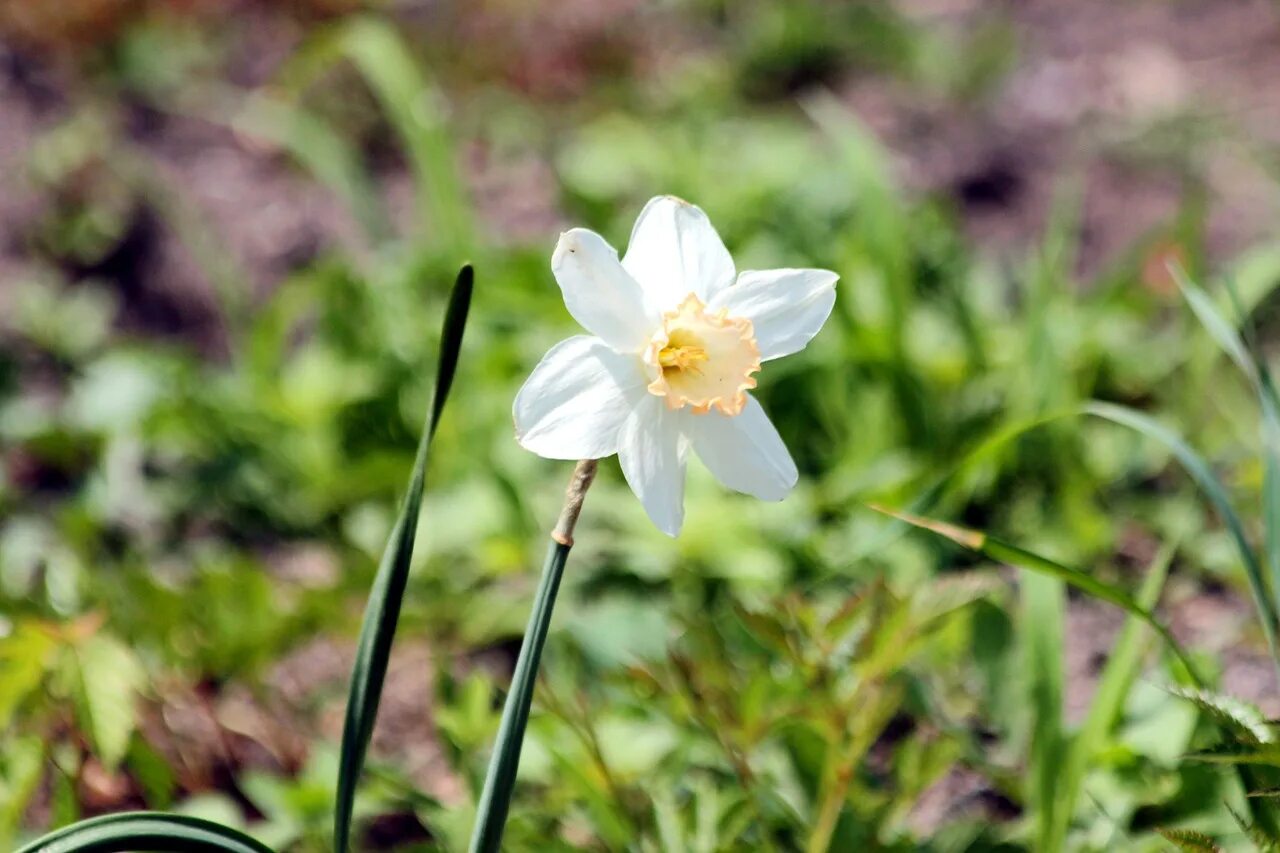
512 334 645 459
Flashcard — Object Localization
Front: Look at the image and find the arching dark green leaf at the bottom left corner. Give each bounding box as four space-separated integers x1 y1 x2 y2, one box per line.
18 812 271 853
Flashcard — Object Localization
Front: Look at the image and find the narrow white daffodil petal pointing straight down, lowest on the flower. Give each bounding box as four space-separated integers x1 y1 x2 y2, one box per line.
618 396 685 537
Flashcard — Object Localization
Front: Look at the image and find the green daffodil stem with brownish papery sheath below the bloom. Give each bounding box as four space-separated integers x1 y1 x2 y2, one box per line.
471 460 596 853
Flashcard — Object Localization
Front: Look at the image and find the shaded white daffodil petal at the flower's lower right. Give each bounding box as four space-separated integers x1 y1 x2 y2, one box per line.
686 394 799 501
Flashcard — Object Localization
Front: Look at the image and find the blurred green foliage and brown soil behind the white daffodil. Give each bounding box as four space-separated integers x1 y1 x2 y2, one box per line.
0 0 1280 853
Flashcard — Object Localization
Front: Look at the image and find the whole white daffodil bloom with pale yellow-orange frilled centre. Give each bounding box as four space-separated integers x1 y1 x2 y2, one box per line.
513 196 837 535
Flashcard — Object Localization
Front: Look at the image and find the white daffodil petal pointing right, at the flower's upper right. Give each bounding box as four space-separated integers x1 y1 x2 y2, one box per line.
708 269 840 361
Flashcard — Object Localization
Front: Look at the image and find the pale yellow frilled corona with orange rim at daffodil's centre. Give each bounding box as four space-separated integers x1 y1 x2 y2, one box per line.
644 293 760 415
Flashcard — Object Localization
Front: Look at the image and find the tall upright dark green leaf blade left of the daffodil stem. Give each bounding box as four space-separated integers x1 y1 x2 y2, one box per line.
333 265 475 853
